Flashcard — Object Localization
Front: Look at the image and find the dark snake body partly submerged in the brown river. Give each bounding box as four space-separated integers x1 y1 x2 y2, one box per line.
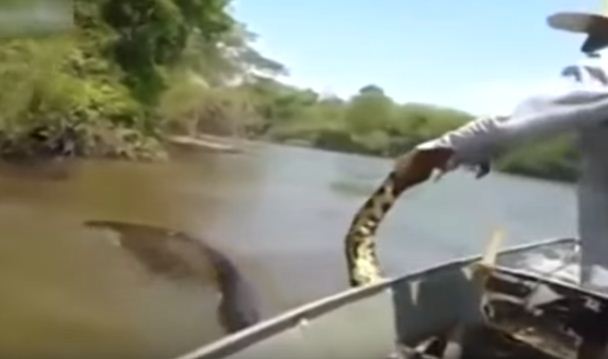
85 221 260 333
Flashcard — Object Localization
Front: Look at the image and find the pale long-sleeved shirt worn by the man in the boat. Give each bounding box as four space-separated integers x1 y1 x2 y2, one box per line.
418 49 608 282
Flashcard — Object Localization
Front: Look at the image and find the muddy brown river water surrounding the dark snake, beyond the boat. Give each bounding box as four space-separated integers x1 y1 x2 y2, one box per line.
0 144 576 359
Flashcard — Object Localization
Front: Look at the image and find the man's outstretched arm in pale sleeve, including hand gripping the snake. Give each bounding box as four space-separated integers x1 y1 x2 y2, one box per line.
395 84 608 192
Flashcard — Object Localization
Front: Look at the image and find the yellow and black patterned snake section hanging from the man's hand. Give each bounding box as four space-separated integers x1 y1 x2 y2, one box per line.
345 171 403 287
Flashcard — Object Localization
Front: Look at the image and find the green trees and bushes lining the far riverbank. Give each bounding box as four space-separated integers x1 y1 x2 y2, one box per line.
0 0 578 182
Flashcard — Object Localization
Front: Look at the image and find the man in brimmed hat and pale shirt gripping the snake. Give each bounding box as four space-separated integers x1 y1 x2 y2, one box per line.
395 6 608 287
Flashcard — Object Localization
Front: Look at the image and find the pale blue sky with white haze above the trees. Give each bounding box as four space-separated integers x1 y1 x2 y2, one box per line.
232 0 601 114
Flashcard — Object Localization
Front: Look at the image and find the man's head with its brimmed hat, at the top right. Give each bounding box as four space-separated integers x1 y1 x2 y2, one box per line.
547 0 608 53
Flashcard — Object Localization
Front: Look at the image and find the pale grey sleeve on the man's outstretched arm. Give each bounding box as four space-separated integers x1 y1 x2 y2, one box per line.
418 88 608 166
